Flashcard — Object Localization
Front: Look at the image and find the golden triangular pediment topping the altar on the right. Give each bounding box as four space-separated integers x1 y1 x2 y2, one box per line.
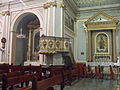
85 11 119 30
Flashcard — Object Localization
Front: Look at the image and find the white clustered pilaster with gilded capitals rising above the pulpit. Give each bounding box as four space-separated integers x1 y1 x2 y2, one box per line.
43 0 66 37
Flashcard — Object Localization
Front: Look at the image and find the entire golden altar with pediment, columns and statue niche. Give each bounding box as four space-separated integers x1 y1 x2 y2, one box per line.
84 12 118 62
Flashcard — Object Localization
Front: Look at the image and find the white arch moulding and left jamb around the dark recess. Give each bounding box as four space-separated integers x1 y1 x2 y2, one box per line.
9 10 43 63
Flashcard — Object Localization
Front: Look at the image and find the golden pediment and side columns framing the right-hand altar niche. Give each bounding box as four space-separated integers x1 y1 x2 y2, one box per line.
83 12 119 62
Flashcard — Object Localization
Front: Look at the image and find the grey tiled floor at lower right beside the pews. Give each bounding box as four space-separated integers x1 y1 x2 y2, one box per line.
54 78 120 90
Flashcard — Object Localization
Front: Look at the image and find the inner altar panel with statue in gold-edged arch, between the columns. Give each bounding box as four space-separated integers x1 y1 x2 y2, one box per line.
91 30 113 62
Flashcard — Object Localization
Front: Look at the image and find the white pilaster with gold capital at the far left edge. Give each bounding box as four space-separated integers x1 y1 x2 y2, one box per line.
1 10 10 63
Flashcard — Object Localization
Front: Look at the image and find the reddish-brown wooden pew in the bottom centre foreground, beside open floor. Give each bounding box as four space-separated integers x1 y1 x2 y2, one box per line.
32 74 64 90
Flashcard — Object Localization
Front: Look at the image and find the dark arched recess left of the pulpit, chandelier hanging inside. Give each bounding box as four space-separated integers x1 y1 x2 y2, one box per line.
12 13 40 65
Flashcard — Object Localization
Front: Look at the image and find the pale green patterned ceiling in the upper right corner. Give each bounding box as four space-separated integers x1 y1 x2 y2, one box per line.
72 0 120 8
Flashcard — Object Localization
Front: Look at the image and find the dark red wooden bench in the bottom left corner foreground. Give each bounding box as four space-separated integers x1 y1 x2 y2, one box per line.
2 73 41 90
